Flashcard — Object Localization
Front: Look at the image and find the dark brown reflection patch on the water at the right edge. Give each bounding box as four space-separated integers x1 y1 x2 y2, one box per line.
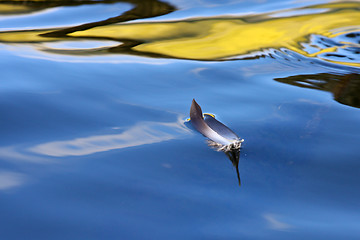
274 73 360 108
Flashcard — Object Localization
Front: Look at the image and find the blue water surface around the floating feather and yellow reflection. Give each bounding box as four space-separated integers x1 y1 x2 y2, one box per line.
0 1 360 239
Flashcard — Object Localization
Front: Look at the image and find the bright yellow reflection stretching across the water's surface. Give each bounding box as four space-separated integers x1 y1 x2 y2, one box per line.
0 2 360 67
